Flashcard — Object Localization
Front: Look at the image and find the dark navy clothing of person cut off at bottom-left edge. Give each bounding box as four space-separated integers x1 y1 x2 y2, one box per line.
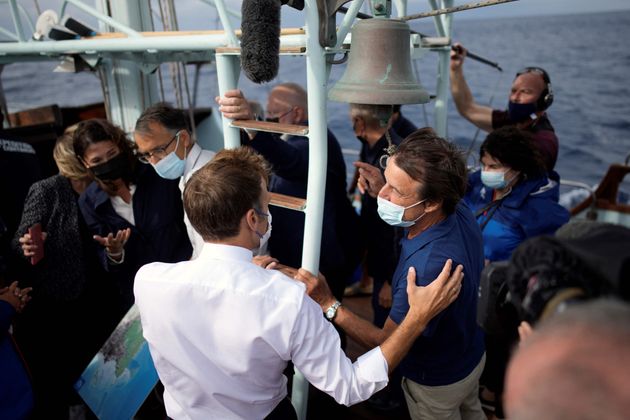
0 300 33 420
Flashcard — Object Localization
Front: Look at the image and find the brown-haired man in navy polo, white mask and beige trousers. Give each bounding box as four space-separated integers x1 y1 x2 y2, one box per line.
298 133 485 419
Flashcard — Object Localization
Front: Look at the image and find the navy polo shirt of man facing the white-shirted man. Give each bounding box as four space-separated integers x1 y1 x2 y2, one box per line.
389 202 484 386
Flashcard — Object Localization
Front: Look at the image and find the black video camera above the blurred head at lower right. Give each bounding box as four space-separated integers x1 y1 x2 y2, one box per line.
477 222 630 334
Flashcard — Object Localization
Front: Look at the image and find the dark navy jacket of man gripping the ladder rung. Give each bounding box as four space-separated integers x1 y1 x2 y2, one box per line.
249 131 359 295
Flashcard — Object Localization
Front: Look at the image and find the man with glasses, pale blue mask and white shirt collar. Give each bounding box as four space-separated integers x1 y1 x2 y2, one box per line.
133 103 214 259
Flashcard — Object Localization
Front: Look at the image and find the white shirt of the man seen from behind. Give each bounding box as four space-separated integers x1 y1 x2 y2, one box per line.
134 243 388 420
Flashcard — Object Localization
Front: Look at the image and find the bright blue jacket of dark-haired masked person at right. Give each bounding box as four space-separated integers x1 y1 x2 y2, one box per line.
464 171 569 261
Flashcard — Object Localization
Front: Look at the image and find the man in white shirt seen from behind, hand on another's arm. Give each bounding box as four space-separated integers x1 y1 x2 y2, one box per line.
135 148 463 419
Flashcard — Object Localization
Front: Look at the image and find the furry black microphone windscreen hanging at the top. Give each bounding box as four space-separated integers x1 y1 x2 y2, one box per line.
241 0 280 83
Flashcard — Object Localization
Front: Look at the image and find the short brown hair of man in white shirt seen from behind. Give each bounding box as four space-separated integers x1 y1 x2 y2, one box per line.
184 147 269 241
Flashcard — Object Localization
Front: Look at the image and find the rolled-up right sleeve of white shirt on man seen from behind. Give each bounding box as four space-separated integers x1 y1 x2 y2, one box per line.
290 297 389 406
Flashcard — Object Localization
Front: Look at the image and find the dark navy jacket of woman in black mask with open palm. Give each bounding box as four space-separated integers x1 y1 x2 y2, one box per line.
79 164 192 309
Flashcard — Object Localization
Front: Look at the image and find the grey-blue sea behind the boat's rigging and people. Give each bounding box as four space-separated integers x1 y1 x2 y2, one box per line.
2 11 630 192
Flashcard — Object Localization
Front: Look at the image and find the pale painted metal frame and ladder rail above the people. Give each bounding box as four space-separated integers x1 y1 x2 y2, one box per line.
0 0 464 419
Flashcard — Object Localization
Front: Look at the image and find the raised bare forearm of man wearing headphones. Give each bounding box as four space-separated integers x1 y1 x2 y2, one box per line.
450 44 492 132
